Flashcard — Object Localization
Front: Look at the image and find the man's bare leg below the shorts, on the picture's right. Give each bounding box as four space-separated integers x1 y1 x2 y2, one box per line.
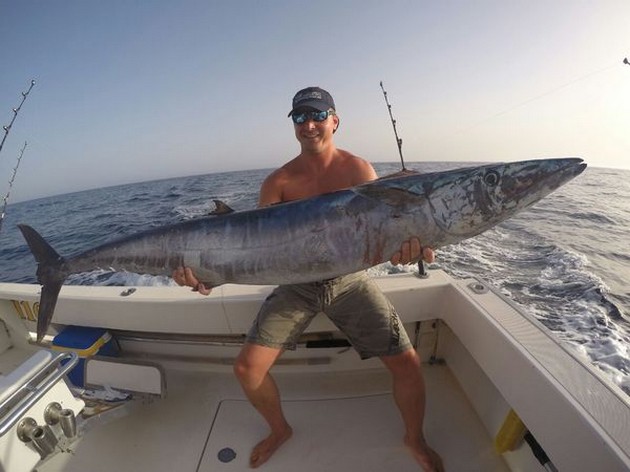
381 349 444 472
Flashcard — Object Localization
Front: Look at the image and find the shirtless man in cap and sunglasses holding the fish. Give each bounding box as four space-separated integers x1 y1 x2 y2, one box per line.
173 87 444 472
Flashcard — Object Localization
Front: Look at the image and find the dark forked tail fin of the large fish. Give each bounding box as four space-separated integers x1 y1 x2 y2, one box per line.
18 224 68 341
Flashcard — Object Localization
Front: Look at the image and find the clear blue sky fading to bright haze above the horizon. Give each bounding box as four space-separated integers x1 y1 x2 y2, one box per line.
0 0 630 201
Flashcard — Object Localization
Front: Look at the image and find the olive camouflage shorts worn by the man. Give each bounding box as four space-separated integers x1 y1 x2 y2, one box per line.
247 272 412 359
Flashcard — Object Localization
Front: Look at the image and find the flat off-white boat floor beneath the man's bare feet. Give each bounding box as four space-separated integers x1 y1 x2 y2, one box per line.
41 365 509 472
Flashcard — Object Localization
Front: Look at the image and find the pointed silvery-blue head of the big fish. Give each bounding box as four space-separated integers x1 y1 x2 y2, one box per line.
425 158 586 244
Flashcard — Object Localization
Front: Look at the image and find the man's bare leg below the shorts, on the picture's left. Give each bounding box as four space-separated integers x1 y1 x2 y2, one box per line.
234 343 293 468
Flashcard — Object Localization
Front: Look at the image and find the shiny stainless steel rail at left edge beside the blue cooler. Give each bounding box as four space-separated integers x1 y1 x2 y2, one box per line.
0 352 79 437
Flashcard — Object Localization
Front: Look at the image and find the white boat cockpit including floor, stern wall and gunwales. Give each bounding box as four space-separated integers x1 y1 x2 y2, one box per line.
0 271 630 472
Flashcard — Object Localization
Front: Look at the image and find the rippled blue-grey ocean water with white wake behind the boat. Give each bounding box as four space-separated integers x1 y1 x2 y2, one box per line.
0 163 630 394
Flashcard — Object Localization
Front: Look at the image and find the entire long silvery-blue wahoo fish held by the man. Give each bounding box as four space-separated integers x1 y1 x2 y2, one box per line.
19 158 586 340
